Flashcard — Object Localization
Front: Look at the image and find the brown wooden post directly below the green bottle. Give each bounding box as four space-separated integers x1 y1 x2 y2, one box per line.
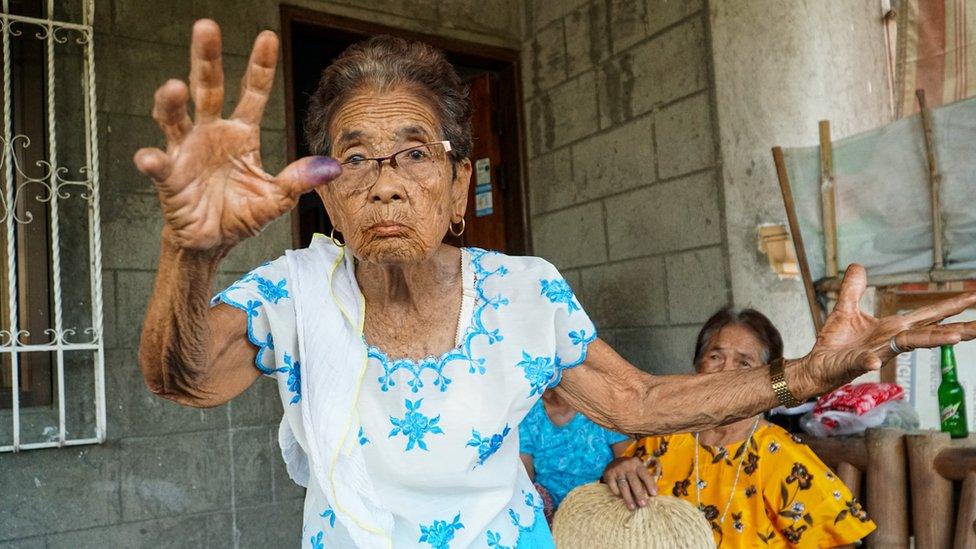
906 431 953 549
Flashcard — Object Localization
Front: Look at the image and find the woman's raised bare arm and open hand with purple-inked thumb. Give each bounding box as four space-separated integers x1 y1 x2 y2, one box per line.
134 19 341 406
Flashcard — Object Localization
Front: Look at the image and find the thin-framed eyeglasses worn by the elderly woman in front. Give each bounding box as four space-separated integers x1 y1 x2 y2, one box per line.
331 141 451 192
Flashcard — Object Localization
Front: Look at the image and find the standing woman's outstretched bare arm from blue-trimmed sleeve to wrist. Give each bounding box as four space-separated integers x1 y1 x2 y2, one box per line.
557 340 818 436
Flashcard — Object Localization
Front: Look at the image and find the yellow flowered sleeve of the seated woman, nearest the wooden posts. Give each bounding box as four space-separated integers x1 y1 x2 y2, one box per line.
760 436 875 547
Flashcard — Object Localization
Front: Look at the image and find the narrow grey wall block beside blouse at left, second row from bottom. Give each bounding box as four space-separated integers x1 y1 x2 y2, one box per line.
230 426 277 506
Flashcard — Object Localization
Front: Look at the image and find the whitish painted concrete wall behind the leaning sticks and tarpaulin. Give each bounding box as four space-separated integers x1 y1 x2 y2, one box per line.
709 0 892 356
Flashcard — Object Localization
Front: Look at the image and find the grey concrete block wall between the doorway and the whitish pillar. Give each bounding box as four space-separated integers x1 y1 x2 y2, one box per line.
522 0 731 373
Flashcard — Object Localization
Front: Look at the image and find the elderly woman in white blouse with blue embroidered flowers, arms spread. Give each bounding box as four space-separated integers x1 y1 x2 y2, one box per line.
135 20 976 548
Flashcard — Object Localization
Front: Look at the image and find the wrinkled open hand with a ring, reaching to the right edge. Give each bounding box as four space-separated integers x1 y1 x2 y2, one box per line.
805 264 976 392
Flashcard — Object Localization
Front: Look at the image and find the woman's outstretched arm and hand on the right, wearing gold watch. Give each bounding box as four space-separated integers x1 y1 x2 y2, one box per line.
556 265 976 436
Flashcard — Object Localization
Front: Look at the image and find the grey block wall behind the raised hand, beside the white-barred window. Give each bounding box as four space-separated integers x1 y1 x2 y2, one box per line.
0 0 521 548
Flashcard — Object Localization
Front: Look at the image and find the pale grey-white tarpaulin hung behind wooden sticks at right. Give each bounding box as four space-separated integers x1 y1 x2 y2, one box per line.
783 98 976 280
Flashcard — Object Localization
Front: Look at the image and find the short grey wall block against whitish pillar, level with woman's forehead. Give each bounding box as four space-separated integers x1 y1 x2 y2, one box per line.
655 93 715 178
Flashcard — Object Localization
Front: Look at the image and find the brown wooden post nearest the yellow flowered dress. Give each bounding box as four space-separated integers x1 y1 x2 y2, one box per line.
865 429 922 549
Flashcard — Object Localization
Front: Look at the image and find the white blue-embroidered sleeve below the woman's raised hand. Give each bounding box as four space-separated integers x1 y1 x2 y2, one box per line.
210 258 297 375
